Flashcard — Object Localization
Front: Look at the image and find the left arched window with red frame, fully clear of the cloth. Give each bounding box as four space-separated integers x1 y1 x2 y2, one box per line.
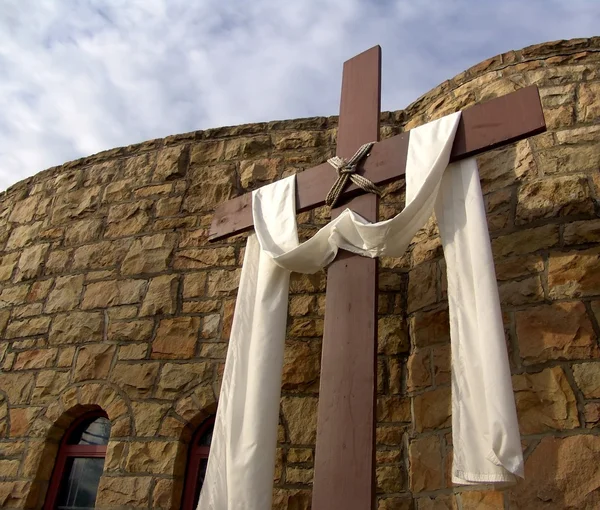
44 410 110 510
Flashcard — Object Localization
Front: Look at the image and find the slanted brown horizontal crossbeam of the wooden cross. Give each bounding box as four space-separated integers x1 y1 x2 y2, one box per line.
209 86 546 241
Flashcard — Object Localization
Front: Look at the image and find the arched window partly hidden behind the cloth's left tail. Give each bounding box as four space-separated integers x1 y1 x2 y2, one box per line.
181 417 215 510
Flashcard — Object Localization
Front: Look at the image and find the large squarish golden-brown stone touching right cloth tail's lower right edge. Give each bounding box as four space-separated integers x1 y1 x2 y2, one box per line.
512 367 579 434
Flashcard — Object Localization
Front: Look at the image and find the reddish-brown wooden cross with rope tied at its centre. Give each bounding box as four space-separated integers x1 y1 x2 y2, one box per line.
209 46 546 510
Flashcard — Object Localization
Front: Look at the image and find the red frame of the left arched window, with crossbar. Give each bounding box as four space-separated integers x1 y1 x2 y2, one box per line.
43 409 108 510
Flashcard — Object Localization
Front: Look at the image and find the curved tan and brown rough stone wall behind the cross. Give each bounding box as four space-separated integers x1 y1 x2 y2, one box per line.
0 38 600 510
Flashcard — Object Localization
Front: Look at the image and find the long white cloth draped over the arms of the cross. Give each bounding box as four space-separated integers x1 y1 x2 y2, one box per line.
198 113 523 510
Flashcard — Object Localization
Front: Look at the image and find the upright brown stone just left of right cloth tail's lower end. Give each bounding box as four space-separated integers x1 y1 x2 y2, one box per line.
408 436 443 492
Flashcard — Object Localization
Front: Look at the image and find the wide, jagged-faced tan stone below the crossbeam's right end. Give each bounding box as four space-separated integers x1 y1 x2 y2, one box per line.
516 175 594 225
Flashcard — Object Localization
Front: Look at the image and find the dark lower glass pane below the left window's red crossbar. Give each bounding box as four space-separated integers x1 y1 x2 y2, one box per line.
56 457 104 510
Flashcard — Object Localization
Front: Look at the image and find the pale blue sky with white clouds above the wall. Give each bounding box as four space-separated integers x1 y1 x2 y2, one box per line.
0 0 600 189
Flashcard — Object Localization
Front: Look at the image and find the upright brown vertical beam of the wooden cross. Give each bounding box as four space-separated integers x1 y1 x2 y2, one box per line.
312 46 381 510
